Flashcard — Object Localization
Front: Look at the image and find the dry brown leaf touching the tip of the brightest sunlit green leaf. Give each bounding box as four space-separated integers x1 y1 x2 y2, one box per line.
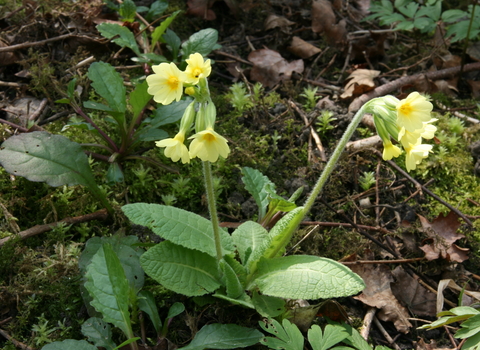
350 264 412 333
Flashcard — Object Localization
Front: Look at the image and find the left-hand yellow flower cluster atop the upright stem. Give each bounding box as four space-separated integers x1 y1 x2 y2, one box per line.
147 53 230 164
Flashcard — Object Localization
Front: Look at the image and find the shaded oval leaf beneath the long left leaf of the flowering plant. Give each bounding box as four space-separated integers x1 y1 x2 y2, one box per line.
140 241 220 296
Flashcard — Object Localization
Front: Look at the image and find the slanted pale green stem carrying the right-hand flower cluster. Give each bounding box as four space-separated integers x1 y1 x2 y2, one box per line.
304 104 368 215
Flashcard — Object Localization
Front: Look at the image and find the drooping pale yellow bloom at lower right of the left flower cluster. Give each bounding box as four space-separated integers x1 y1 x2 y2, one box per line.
189 128 230 163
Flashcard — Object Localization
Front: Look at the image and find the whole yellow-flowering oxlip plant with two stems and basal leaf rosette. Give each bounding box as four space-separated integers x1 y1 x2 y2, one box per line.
122 53 436 317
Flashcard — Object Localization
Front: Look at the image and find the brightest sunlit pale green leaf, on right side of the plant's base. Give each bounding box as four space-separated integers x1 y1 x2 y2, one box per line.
255 255 365 299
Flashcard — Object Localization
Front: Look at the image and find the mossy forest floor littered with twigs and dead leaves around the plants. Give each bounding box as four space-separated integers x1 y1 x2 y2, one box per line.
0 0 480 350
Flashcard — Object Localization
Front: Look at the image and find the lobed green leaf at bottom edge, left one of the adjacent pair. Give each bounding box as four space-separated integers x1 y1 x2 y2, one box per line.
259 319 304 350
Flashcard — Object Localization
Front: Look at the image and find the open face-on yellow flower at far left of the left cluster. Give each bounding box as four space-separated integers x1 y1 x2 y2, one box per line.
147 62 186 105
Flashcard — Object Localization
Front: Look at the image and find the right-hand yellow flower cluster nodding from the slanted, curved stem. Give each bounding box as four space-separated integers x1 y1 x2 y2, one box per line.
368 92 437 171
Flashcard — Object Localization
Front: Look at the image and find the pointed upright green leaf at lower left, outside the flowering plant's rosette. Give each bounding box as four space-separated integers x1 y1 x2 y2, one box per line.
85 243 132 338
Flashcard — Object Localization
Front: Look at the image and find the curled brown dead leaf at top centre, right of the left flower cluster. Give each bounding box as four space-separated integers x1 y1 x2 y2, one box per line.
248 49 304 88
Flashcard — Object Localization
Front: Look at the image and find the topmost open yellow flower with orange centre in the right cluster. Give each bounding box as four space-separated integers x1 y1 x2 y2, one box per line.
397 92 433 132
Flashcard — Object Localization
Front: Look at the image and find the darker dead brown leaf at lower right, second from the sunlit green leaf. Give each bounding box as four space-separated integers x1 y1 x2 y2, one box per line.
391 266 437 317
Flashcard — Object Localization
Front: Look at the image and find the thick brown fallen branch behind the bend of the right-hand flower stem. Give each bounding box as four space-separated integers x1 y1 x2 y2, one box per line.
348 62 480 114
